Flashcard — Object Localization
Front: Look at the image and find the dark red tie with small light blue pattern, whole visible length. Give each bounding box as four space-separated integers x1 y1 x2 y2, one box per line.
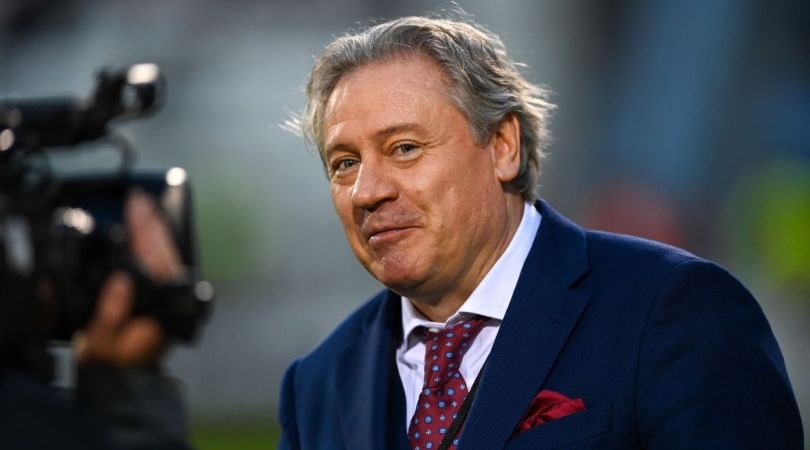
408 316 487 450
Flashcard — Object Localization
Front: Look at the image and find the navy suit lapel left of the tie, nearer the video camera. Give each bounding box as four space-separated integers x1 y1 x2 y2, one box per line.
336 292 402 449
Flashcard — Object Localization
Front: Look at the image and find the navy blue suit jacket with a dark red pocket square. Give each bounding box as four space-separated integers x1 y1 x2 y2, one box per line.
280 202 803 450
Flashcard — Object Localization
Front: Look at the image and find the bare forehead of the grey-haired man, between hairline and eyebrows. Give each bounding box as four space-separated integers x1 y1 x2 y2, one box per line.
323 53 456 150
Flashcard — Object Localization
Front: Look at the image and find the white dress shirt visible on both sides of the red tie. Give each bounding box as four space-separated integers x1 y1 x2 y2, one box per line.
397 203 541 429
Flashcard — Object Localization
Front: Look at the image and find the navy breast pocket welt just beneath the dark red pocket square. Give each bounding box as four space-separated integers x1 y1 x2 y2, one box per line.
506 403 613 450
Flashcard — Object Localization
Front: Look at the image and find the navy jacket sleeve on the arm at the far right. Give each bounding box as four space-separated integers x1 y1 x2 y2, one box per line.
636 260 803 450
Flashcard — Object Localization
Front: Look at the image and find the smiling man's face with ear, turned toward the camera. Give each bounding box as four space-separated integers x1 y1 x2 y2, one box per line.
324 55 522 304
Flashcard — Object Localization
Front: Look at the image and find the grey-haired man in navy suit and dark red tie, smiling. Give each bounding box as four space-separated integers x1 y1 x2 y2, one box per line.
280 17 802 450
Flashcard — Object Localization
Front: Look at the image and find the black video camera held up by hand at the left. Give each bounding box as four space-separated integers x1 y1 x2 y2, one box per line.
0 64 213 352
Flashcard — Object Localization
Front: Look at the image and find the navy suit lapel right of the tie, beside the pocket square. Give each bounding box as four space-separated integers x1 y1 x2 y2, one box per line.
460 203 589 450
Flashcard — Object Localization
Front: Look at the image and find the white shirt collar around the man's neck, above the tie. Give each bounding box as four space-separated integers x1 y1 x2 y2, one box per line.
401 203 542 342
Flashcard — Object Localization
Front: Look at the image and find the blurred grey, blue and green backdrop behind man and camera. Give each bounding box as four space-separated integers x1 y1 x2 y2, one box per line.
0 0 810 449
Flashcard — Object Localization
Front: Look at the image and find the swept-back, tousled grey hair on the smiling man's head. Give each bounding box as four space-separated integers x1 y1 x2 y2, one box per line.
291 17 554 202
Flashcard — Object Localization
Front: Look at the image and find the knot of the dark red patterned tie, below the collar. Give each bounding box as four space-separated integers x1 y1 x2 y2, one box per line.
422 316 487 387
